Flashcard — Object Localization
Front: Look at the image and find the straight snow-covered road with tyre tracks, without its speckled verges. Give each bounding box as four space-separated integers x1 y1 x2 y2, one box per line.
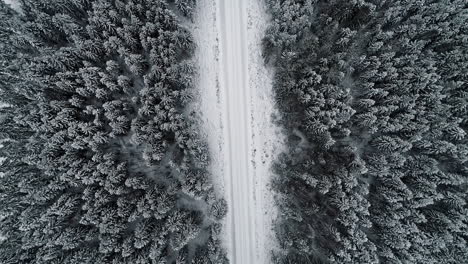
219 0 256 263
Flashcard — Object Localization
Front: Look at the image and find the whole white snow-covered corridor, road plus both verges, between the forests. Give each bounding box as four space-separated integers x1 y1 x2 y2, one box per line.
192 0 283 264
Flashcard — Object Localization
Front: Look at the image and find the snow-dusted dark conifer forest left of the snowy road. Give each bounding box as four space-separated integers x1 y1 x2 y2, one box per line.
0 0 225 264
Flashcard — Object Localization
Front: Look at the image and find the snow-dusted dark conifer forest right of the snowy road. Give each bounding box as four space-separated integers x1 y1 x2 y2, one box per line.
264 0 468 263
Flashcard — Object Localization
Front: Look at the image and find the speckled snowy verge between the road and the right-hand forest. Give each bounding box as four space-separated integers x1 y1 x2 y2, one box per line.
246 0 284 264
